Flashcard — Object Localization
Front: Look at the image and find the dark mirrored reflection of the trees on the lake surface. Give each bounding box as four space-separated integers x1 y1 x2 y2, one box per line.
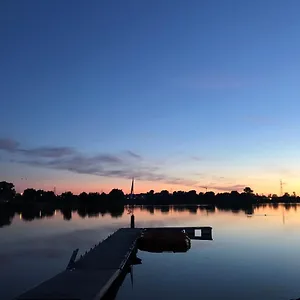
0 203 298 227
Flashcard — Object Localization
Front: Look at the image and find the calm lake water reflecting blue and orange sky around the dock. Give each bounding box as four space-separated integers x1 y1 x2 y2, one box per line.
0 206 300 300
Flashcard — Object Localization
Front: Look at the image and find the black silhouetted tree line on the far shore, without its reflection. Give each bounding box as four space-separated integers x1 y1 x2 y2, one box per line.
0 181 300 207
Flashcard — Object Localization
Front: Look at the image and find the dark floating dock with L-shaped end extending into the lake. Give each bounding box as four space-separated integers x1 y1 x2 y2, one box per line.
16 227 212 300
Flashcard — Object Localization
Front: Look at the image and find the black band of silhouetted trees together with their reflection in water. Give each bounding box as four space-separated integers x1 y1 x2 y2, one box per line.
0 181 300 227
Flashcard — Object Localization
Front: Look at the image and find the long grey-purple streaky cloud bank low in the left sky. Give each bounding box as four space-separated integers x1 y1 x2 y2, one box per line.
0 139 197 187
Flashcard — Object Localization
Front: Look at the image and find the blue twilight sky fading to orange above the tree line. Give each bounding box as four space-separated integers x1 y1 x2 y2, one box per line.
0 0 300 194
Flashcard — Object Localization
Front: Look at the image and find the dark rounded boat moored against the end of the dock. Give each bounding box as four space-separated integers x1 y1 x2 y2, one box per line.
137 229 191 253
